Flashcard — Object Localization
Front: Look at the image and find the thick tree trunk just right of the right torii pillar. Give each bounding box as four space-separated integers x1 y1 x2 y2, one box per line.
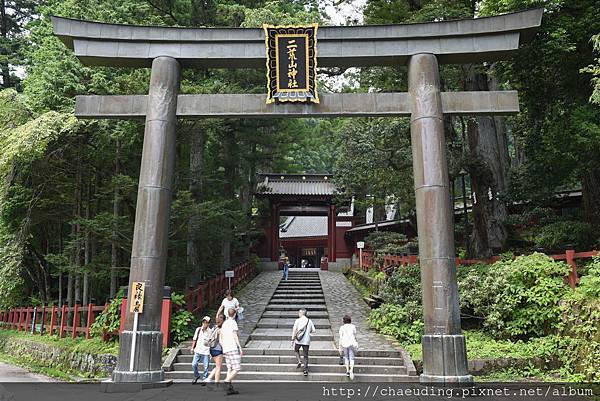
466 67 510 257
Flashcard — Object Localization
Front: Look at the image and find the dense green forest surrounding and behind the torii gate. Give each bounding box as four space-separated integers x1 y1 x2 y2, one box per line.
0 0 600 307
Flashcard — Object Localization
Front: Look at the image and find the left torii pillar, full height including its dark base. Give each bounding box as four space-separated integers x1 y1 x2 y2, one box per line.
112 57 180 383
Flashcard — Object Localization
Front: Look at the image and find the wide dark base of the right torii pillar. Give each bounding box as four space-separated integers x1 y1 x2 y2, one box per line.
420 334 473 384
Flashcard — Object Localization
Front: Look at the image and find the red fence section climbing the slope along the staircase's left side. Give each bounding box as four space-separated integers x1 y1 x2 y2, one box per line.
185 262 254 315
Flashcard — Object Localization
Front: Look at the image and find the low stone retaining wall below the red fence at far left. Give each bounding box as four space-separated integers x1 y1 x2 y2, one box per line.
0 338 117 377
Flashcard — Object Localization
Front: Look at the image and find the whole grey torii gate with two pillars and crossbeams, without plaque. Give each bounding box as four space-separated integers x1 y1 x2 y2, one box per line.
52 9 543 382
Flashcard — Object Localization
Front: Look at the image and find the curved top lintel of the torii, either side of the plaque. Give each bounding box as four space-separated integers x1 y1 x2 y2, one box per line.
52 8 543 68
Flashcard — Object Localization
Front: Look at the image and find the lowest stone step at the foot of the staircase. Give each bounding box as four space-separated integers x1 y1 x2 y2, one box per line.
165 366 419 383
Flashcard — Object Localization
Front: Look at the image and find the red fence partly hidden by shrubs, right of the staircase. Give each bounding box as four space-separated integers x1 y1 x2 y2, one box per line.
361 249 598 288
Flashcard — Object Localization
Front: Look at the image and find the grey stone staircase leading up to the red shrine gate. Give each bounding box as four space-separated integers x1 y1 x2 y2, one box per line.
165 269 418 382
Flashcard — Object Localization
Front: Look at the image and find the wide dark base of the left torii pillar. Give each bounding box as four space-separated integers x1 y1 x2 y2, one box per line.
112 330 165 383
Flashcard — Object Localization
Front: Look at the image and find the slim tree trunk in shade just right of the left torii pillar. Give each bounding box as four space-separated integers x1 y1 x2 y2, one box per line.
187 129 204 286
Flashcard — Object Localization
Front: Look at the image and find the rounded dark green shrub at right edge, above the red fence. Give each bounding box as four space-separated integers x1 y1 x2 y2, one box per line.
535 221 595 251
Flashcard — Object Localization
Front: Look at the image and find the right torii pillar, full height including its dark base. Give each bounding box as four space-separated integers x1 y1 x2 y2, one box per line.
408 54 473 383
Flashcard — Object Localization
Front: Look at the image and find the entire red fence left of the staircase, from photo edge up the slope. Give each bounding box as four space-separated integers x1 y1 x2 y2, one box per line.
0 262 254 347
